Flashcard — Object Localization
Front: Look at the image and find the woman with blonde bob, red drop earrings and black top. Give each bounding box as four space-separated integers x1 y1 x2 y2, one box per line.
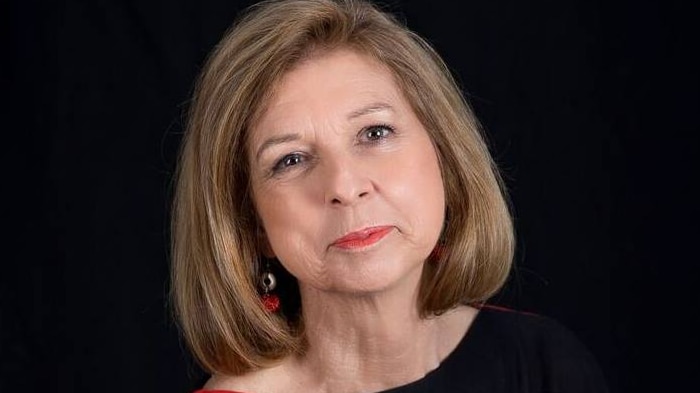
173 0 605 393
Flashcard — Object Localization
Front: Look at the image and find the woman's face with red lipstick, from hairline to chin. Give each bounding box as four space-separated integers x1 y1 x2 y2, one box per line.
248 50 445 293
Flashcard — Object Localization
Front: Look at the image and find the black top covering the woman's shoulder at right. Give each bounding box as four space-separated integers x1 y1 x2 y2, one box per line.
382 307 608 393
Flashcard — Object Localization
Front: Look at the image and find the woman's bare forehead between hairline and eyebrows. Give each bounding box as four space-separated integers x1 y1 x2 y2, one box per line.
251 49 406 138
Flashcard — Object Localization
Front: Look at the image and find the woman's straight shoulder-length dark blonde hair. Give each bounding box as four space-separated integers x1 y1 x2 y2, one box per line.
172 0 514 374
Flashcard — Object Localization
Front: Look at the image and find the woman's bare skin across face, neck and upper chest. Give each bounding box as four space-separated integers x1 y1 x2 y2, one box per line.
206 50 476 393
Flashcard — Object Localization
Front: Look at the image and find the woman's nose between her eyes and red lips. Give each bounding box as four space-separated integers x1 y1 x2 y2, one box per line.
322 152 374 206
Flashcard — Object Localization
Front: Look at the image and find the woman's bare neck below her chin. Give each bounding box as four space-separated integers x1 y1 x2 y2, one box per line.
292 274 442 392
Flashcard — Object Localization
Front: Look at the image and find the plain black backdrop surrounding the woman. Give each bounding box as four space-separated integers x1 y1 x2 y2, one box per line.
0 0 700 392
